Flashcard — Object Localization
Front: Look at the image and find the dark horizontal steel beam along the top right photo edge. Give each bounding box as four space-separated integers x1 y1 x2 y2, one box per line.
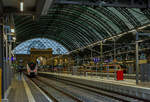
55 0 150 8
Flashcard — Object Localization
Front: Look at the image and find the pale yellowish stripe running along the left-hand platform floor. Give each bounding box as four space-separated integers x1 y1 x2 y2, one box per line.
22 76 36 102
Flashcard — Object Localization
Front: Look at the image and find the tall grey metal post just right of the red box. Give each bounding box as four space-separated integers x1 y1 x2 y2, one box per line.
136 32 139 84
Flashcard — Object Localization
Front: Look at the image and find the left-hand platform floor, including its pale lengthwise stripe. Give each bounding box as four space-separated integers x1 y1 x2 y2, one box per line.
8 74 52 102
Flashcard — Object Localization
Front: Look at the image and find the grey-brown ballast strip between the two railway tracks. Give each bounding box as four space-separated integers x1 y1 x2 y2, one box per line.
38 77 110 102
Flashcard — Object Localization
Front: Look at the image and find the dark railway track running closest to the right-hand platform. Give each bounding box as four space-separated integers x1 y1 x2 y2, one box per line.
39 77 146 102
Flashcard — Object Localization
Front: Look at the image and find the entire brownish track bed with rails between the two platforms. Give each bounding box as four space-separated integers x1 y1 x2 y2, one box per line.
25 72 148 102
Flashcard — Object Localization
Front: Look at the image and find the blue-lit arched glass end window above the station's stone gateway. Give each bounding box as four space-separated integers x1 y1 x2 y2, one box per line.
13 38 68 54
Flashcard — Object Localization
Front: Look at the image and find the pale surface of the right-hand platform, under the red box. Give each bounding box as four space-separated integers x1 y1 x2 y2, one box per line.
40 72 150 89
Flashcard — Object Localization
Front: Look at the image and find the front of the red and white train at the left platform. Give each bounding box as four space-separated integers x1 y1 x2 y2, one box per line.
27 62 38 76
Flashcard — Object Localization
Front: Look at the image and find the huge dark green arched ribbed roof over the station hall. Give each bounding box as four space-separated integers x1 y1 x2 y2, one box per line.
14 4 150 50
